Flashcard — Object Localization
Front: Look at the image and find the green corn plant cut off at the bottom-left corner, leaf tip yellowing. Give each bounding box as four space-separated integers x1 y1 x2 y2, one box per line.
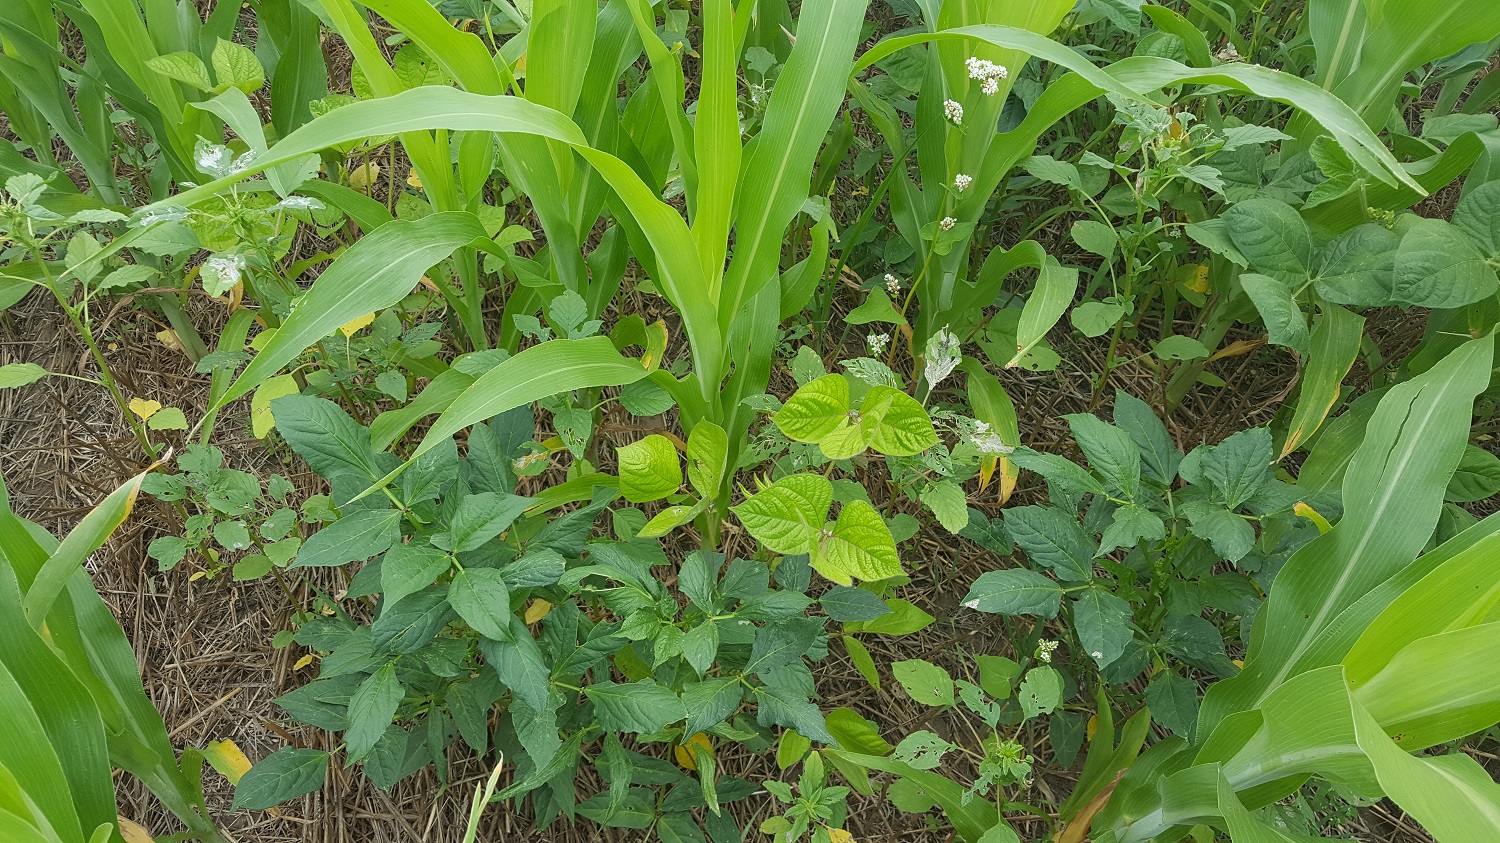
0 476 222 843
